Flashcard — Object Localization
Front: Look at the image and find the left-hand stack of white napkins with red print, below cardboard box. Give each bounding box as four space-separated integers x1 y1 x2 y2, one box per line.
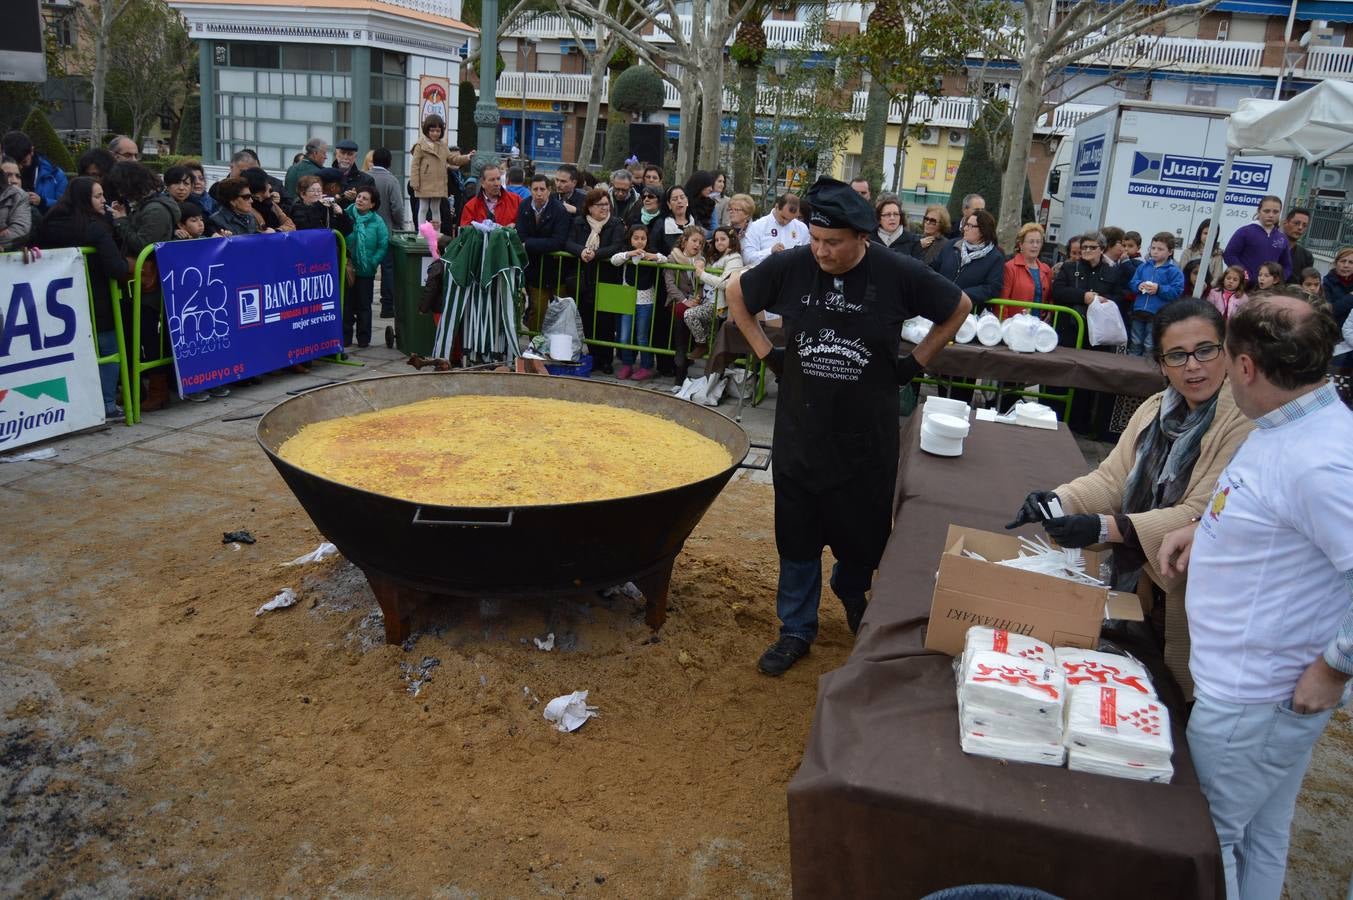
958 628 1066 766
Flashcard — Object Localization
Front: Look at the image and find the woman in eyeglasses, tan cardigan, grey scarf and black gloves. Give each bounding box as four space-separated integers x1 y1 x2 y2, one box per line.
1007 297 1253 700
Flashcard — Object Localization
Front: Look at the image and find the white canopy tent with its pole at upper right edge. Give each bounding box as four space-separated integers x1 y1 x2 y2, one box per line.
1195 81 1353 296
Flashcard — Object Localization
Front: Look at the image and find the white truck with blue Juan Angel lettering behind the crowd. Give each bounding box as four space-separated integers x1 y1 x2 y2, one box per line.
1046 102 1293 258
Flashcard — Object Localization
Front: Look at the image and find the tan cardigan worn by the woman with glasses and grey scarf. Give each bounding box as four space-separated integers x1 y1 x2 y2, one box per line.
1054 384 1254 700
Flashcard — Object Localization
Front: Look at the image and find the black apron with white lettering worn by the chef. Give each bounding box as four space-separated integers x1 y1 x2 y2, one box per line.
774 254 898 570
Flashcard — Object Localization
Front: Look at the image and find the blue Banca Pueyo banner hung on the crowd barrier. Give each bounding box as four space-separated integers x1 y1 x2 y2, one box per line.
156 230 342 395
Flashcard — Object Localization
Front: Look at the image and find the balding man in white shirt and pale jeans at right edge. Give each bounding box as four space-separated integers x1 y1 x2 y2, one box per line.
1161 292 1353 900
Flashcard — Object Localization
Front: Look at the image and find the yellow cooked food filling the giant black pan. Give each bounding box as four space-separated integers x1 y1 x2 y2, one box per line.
279 395 732 506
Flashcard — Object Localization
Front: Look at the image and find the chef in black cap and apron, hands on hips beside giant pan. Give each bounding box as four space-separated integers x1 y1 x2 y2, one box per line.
727 179 971 675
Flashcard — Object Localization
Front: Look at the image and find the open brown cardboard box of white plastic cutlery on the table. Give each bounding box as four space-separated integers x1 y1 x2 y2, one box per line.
925 525 1142 656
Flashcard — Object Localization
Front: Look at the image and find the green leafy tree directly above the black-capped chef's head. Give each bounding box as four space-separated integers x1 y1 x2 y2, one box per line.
838 0 1008 192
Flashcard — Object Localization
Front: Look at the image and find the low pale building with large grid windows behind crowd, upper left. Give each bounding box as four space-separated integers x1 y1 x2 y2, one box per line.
170 0 474 175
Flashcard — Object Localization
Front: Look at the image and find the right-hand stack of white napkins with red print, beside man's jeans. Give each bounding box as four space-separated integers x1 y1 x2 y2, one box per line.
1057 647 1174 782
